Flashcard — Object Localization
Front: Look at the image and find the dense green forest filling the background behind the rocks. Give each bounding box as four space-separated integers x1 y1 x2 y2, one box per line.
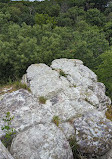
0 0 112 98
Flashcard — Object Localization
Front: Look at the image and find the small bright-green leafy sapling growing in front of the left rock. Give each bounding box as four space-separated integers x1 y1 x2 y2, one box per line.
1 112 16 148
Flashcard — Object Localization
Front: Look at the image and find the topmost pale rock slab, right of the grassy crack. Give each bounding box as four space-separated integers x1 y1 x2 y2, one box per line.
51 59 97 88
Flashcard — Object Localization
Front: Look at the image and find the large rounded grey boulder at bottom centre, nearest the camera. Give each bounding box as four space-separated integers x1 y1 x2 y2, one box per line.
11 124 73 159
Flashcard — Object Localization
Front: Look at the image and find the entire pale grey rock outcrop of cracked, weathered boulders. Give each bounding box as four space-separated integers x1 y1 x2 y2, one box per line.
0 59 112 159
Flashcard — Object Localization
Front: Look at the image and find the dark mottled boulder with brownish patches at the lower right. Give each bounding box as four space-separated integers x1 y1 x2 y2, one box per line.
74 110 112 157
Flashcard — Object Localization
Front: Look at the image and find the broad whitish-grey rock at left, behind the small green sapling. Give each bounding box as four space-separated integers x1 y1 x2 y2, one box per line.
0 89 53 137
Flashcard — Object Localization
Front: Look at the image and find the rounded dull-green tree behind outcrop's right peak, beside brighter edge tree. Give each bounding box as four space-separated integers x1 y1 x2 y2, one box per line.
69 26 109 70
